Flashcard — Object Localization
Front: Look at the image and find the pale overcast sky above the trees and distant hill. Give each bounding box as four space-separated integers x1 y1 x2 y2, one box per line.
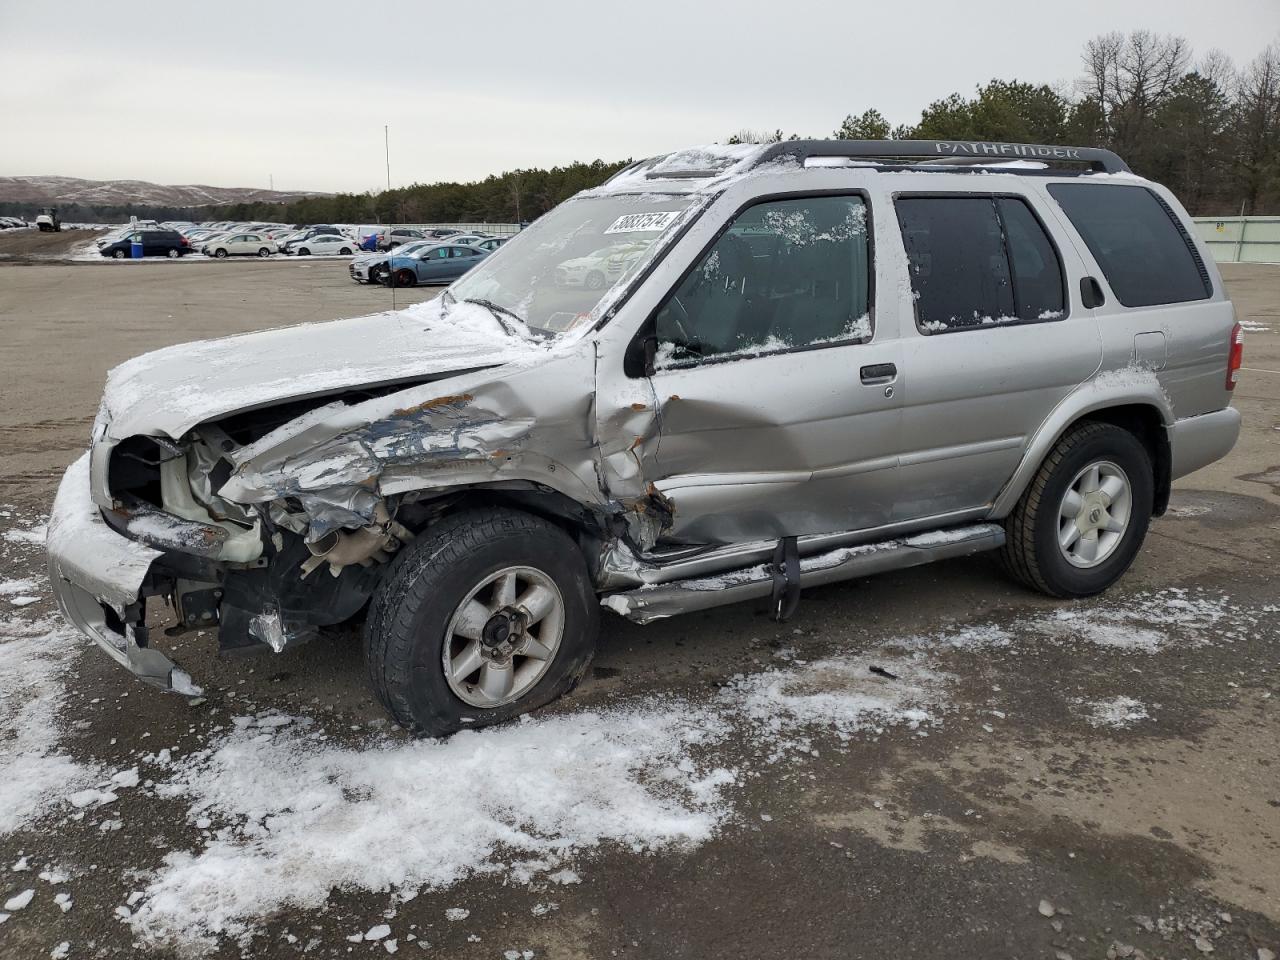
0 0 1280 191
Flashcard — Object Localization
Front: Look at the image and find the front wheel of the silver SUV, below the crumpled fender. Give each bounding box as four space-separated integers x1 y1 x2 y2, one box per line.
365 509 599 736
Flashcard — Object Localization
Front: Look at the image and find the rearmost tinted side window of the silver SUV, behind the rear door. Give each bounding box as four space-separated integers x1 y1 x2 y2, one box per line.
1048 183 1213 307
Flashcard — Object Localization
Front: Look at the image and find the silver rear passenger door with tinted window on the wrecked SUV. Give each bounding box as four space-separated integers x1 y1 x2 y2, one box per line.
893 183 1102 521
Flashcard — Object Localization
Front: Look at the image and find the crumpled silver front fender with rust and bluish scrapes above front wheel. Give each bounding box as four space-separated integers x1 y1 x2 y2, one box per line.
218 348 603 543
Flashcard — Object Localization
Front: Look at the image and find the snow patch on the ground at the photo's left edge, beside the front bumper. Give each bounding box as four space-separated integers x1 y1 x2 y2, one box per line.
0 616 97 835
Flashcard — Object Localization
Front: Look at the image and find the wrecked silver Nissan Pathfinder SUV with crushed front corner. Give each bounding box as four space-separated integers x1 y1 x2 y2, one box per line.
49 142 1242 735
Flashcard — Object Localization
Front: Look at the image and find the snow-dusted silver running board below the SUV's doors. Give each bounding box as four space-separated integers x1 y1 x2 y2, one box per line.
600 524 1005 623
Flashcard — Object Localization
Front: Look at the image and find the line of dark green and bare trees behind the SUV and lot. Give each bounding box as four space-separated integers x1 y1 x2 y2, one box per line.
5 31 1280 223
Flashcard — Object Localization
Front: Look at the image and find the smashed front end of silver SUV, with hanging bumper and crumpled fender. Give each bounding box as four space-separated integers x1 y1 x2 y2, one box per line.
49 330 624 692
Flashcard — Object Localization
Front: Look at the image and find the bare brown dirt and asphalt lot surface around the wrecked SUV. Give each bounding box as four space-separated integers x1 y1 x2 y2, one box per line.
0 262 1280 960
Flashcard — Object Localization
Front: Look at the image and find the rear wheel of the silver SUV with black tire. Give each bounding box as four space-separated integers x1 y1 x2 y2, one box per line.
1000 421 1155 598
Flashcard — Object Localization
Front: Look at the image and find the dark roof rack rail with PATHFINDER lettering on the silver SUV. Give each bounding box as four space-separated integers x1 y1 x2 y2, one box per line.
751 140 1130 173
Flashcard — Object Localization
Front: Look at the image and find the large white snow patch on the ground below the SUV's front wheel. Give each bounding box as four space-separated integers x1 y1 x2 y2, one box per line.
129 701 735 945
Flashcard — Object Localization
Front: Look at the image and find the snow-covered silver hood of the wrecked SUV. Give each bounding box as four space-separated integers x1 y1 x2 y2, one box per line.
102 298 545 439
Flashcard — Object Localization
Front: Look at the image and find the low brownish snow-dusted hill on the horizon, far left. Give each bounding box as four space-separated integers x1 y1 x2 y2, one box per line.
0 177 330 207
